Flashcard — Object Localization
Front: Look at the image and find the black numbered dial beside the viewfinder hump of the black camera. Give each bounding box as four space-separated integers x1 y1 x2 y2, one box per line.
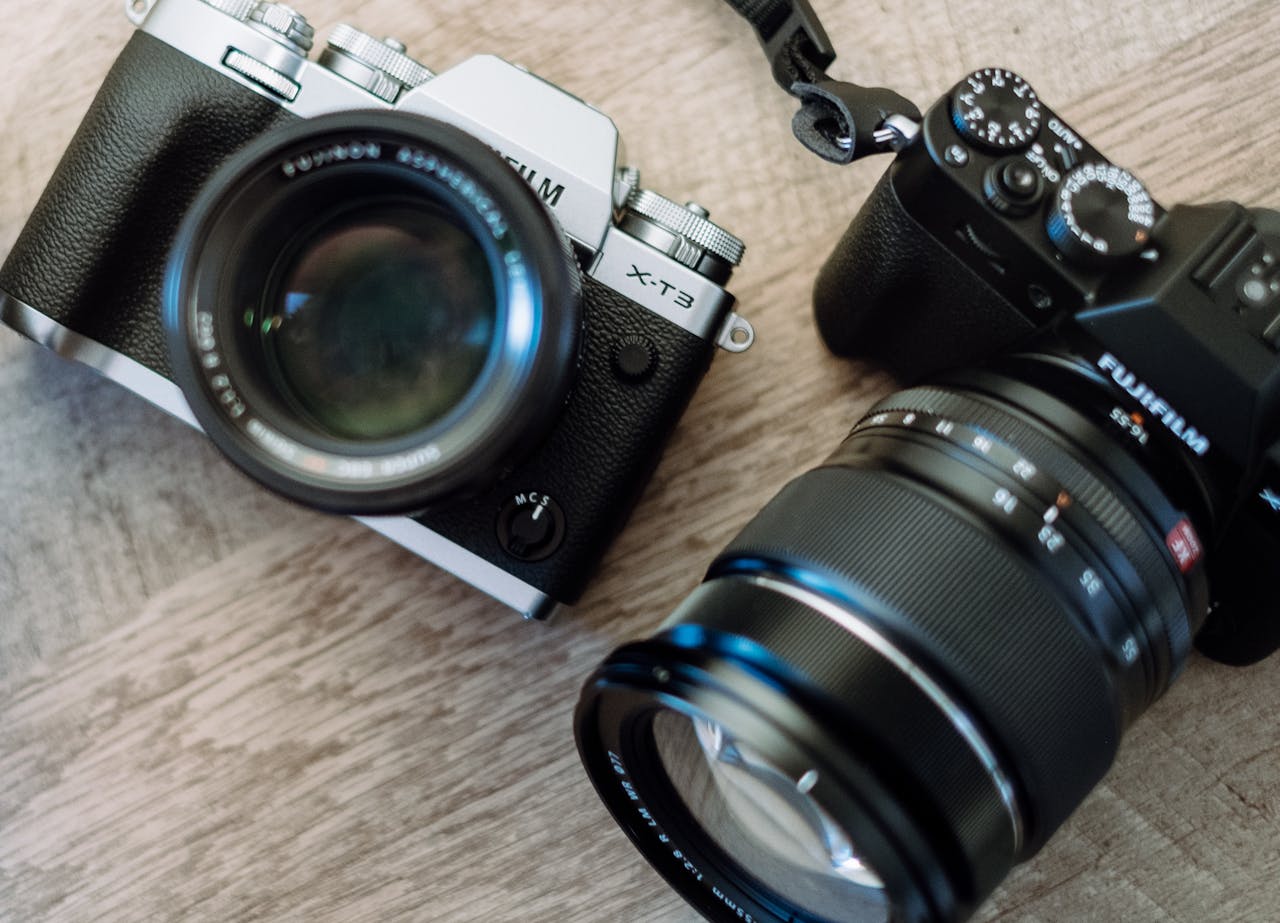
1044 164 1156 266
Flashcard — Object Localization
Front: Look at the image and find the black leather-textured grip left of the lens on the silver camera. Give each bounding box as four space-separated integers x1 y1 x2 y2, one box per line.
0 32 296 378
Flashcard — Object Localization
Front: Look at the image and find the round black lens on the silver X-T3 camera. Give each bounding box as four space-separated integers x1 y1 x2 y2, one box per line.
165 113 581 515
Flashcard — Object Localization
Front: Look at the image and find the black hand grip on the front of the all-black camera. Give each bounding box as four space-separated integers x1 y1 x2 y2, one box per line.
814 163 1034 380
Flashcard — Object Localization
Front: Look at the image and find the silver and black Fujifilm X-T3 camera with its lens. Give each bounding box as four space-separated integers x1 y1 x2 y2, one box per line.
0 0 753 617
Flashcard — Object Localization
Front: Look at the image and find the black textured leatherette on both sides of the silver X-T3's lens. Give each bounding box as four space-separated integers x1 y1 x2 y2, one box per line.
0 32 714 603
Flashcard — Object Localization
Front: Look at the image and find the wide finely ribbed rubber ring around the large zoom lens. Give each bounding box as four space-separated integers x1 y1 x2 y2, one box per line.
711 467 1121 860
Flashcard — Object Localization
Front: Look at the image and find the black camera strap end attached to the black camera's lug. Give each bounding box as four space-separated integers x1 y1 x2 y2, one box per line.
724 0 920 164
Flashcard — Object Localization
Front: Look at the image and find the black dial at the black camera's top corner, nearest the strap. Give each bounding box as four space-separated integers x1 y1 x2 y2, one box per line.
951 68 1043 151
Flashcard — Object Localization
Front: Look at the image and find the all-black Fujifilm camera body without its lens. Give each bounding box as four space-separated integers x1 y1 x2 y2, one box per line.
814 68 1280 663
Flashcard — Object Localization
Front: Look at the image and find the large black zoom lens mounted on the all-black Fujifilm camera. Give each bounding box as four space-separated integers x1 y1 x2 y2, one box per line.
576 355 1207 923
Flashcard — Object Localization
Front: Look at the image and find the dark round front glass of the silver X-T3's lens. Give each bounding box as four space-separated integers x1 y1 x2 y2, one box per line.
262 201 498 440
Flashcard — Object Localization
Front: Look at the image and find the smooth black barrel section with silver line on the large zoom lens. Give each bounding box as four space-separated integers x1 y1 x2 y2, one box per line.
658 578 1023 905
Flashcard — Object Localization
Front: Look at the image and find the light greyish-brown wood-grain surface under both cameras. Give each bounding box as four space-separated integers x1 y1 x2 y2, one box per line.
0 0 1280 923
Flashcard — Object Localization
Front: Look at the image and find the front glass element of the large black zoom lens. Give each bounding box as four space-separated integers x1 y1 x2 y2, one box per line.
653 710 890 923
